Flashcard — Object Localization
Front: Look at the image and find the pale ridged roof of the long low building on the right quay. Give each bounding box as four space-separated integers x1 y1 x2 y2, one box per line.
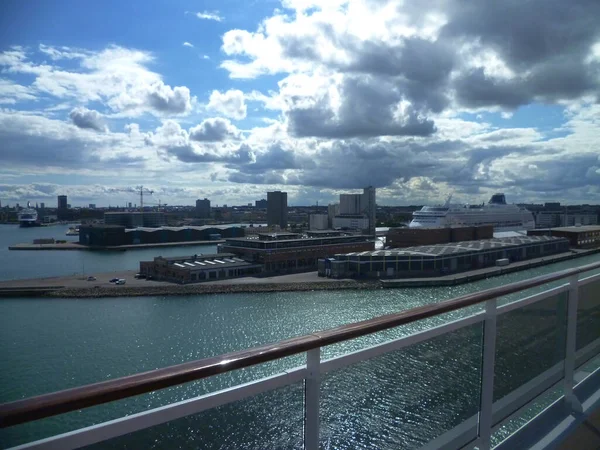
347 236 564 256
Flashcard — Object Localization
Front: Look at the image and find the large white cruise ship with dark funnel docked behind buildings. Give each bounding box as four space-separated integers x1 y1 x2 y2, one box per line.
409 193 535 231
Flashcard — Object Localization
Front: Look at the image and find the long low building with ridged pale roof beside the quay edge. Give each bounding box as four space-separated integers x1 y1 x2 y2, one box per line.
318 236 569 278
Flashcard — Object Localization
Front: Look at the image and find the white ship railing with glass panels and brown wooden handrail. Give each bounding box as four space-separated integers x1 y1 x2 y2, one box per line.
0 262 600 449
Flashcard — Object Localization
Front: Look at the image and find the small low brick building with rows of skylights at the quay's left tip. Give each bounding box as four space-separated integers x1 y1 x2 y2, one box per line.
140 253 262 284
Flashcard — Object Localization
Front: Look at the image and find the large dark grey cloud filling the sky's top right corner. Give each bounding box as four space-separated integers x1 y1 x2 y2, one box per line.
442 0 600 108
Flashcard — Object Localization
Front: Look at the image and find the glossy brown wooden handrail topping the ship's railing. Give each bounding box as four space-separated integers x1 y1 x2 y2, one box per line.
0 262 600 428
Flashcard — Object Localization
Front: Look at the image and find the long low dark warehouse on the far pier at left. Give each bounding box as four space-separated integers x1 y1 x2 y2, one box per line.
79 225 244 247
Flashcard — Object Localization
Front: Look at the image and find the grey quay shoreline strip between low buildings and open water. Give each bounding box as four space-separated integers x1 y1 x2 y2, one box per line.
0 248 600 299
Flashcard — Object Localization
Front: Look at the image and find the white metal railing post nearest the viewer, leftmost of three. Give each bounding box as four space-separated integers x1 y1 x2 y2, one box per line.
304 347 321 450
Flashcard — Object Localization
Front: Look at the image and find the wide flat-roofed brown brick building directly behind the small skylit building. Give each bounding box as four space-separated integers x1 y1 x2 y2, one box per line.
217 232 375 273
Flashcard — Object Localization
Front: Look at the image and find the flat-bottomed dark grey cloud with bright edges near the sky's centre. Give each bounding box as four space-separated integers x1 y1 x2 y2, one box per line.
286 76 435 138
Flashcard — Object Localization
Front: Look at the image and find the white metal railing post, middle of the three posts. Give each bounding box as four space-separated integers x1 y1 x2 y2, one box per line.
478 299 497 450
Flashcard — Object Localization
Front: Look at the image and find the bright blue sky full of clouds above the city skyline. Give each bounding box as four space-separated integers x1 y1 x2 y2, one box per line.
0 0 600 206
